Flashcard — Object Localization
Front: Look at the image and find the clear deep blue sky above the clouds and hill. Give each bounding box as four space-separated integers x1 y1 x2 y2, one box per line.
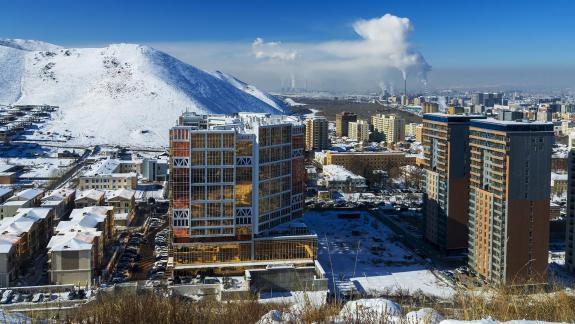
0 0 575 90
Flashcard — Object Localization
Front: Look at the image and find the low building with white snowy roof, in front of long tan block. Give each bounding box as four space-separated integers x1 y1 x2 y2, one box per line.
318 164 367 193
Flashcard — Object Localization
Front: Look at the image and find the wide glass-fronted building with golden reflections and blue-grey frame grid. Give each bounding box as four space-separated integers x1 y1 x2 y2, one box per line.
170 113 317 272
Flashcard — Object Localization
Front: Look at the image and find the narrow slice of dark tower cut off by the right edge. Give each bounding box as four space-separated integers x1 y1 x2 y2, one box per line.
565 133 575 273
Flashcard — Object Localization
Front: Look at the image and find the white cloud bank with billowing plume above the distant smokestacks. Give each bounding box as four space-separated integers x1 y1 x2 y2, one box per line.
150 14 430 90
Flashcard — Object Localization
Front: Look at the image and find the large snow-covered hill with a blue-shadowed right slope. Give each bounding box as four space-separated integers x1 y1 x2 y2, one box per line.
0 40 285 146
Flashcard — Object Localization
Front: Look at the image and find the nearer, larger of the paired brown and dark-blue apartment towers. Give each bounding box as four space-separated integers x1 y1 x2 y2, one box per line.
468 119 554 285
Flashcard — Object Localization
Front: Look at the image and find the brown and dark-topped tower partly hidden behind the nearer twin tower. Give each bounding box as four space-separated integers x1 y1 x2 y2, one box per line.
422 114 485 253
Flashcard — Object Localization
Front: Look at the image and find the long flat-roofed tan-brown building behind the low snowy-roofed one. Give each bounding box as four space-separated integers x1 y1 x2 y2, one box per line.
321 151 415 178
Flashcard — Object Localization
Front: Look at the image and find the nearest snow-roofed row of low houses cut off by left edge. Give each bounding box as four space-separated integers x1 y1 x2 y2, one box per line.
0 208 54 287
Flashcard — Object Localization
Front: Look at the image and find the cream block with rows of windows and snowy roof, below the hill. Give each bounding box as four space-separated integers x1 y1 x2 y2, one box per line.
78 159 138 190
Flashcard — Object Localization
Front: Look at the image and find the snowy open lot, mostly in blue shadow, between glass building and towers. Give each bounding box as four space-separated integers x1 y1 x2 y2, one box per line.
303 211 454 298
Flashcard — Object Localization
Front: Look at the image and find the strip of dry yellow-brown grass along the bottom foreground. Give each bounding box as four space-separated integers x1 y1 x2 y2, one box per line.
27 288 575 324
